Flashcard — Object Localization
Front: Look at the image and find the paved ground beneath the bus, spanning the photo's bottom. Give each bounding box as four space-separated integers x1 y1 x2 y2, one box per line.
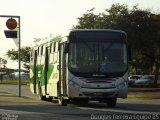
0 85 160 120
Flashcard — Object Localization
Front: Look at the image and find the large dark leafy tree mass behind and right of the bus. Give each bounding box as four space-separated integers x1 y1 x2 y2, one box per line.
74 4 160 84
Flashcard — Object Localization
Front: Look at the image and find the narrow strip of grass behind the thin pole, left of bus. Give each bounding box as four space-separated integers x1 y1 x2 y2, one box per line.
0 80 29 85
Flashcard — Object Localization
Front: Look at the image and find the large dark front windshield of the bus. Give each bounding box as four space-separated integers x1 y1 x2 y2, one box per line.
69 41 127 74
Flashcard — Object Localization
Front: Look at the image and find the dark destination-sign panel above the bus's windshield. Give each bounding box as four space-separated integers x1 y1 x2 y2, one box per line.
69 29 127 43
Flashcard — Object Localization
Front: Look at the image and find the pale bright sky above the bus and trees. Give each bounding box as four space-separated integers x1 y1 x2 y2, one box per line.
0 0 160 68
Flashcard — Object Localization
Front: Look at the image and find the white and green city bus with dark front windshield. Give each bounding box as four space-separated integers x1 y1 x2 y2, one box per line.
30 29 128 107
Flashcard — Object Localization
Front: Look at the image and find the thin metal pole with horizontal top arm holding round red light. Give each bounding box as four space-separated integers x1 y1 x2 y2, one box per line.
0 15 21 97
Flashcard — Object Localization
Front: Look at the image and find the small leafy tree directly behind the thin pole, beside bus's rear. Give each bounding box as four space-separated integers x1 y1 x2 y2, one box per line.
6 47 31 70
